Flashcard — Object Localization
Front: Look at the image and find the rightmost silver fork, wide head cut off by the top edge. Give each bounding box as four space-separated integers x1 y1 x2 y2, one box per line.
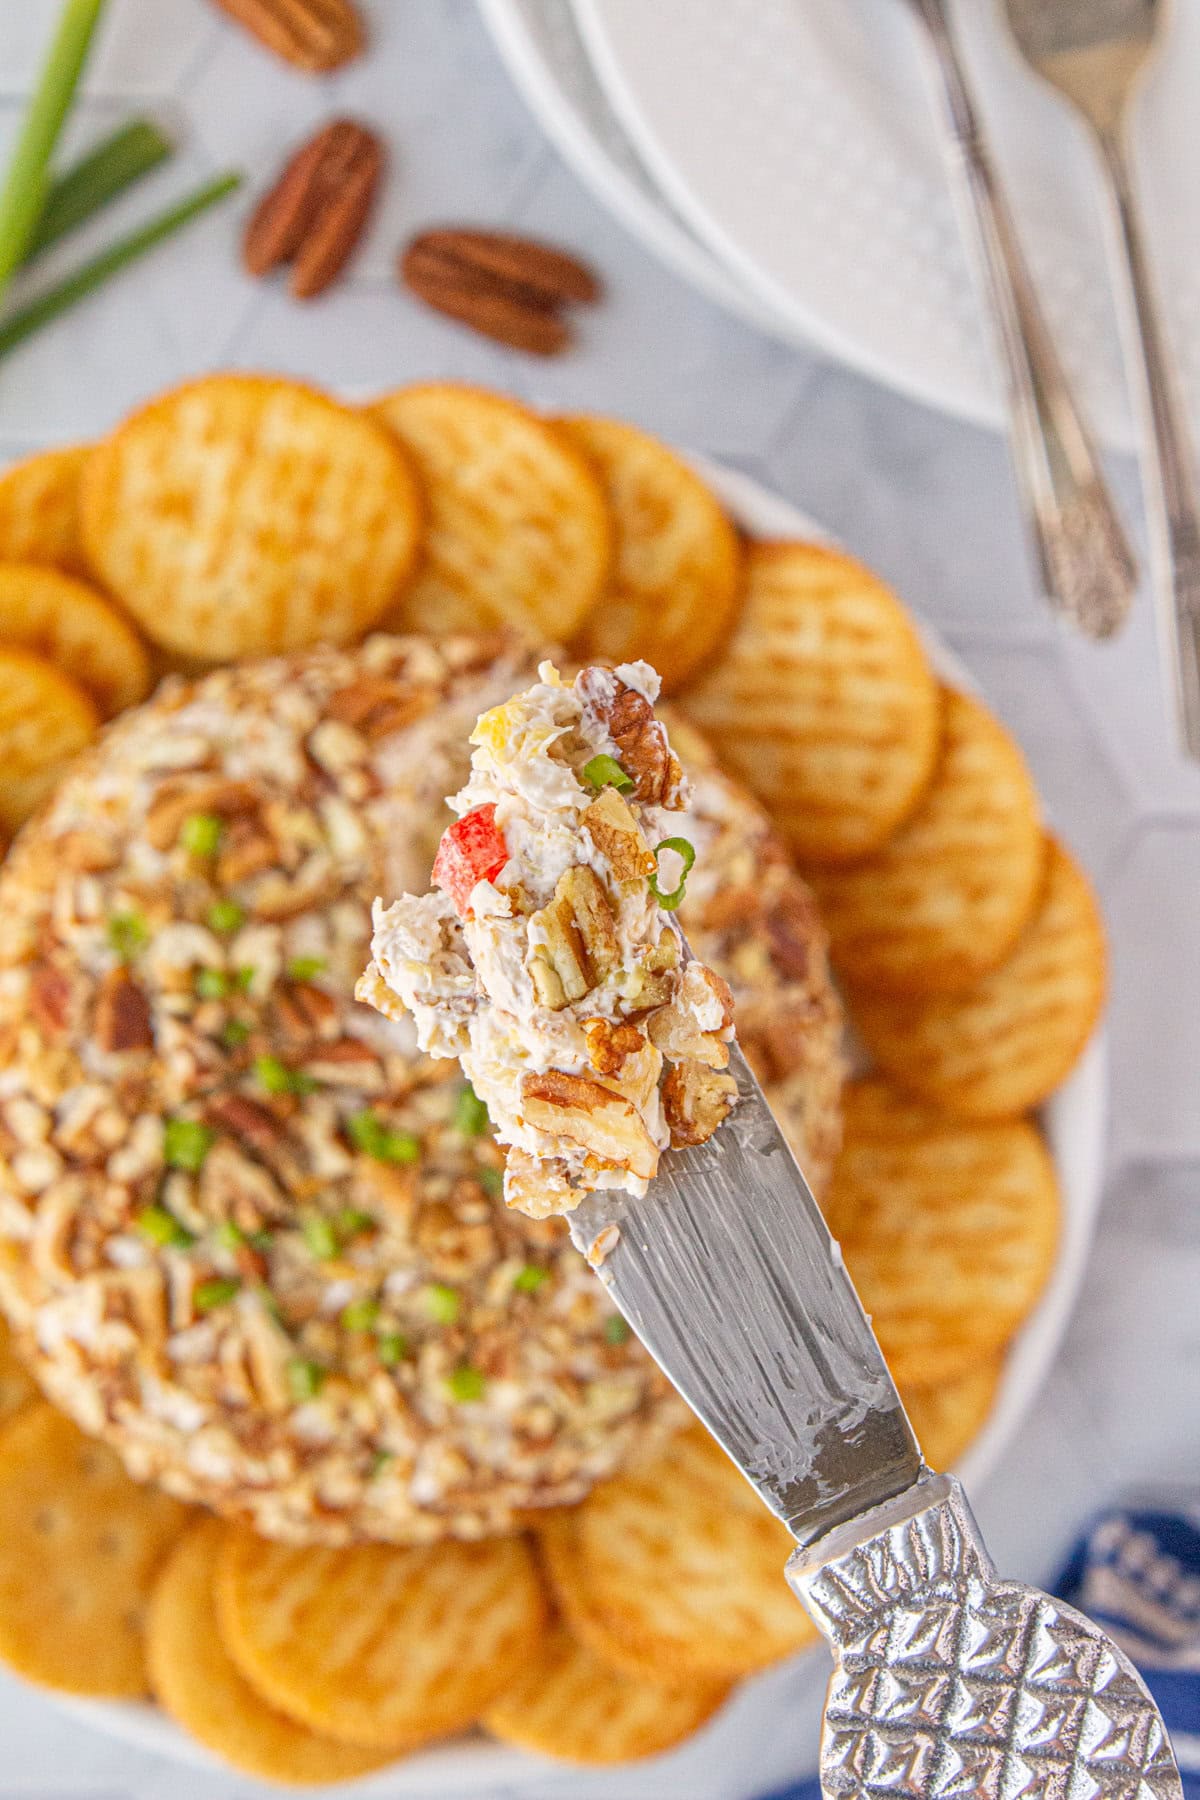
1004 0 1200 760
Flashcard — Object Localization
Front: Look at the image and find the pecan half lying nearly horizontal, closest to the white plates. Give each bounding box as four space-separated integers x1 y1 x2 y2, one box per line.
399 229 601 356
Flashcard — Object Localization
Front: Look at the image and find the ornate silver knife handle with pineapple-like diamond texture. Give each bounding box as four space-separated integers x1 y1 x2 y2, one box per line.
788 1476 1182 1800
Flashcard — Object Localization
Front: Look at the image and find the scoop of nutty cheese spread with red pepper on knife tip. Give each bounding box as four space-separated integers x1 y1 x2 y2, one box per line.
360 662 734 1217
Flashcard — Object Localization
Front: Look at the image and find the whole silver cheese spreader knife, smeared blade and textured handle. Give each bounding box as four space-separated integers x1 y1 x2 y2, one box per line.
569 1046 1182 1800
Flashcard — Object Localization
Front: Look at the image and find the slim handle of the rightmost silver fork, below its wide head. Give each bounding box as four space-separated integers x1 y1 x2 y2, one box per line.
1097 124 1200 760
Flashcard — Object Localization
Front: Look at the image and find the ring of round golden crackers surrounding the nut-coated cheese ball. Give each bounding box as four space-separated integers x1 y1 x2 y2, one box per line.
0 374 1105 1782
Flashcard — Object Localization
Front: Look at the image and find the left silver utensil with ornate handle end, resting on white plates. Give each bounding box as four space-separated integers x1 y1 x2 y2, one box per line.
909 0 1137 637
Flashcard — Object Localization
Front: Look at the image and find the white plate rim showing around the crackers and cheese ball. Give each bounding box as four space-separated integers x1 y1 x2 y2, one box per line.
59 457 1108 1796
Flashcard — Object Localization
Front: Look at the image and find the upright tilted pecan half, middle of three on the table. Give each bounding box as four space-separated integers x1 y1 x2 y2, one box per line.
241 119 383 301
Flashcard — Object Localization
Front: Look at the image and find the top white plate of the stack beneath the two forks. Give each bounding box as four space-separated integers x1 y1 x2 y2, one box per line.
576 0 1200 441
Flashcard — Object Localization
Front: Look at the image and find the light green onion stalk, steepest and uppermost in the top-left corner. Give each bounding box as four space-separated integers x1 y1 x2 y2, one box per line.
0 0 104 295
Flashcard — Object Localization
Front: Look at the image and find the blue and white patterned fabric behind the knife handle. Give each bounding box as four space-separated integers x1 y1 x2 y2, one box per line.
766 1498 1200 1800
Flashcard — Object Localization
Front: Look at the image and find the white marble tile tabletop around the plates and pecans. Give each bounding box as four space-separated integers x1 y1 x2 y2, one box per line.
0 0 1200 1800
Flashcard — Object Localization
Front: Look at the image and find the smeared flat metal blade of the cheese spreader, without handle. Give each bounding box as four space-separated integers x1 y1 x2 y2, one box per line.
569 1044 923 1544
